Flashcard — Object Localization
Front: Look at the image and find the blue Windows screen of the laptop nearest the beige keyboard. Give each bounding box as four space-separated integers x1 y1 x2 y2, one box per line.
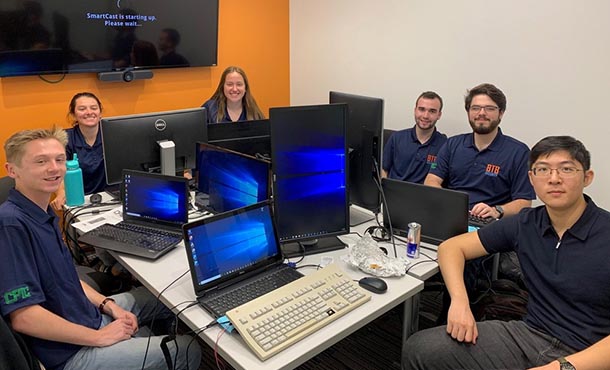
183 202 284 296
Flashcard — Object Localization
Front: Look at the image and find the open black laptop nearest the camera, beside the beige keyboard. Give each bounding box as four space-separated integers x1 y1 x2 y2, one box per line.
182 201 303 317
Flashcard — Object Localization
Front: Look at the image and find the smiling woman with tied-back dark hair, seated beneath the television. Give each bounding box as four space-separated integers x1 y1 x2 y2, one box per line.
51 92 106 210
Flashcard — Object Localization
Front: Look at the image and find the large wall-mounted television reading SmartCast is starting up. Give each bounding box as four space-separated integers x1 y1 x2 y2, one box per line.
0 0 218 77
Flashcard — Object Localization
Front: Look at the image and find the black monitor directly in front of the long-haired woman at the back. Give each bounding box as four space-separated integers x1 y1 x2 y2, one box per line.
208 119 271 158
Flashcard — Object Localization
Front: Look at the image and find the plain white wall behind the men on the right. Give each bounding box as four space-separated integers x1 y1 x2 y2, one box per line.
290 0 610 209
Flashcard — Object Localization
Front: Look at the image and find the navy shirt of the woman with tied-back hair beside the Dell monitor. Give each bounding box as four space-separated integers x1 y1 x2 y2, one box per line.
66 126 106 194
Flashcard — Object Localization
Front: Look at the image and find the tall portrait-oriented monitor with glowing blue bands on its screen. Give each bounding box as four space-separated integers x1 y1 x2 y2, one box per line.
269 104 349 257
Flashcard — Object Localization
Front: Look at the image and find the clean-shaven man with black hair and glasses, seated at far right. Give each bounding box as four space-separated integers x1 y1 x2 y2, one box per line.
402 136 610 370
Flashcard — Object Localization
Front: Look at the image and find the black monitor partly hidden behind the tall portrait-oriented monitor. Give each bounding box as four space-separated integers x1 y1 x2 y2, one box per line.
329 91 383 226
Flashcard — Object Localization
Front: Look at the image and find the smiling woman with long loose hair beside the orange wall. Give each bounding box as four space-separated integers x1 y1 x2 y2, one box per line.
203 66 265 123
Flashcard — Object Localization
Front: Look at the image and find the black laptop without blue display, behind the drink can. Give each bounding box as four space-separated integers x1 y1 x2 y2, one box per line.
381 178 468 245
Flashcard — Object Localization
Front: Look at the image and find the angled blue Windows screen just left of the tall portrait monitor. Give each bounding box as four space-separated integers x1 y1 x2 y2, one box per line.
196 143 271 213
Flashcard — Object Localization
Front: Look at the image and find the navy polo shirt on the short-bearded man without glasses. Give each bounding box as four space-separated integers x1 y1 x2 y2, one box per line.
383 126 447 184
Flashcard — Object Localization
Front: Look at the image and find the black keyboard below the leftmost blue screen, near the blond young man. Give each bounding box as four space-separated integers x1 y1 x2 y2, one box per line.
87 222 182 251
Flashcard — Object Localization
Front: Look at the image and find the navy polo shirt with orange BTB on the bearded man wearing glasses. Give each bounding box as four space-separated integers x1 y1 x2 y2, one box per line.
430 129 536 208
